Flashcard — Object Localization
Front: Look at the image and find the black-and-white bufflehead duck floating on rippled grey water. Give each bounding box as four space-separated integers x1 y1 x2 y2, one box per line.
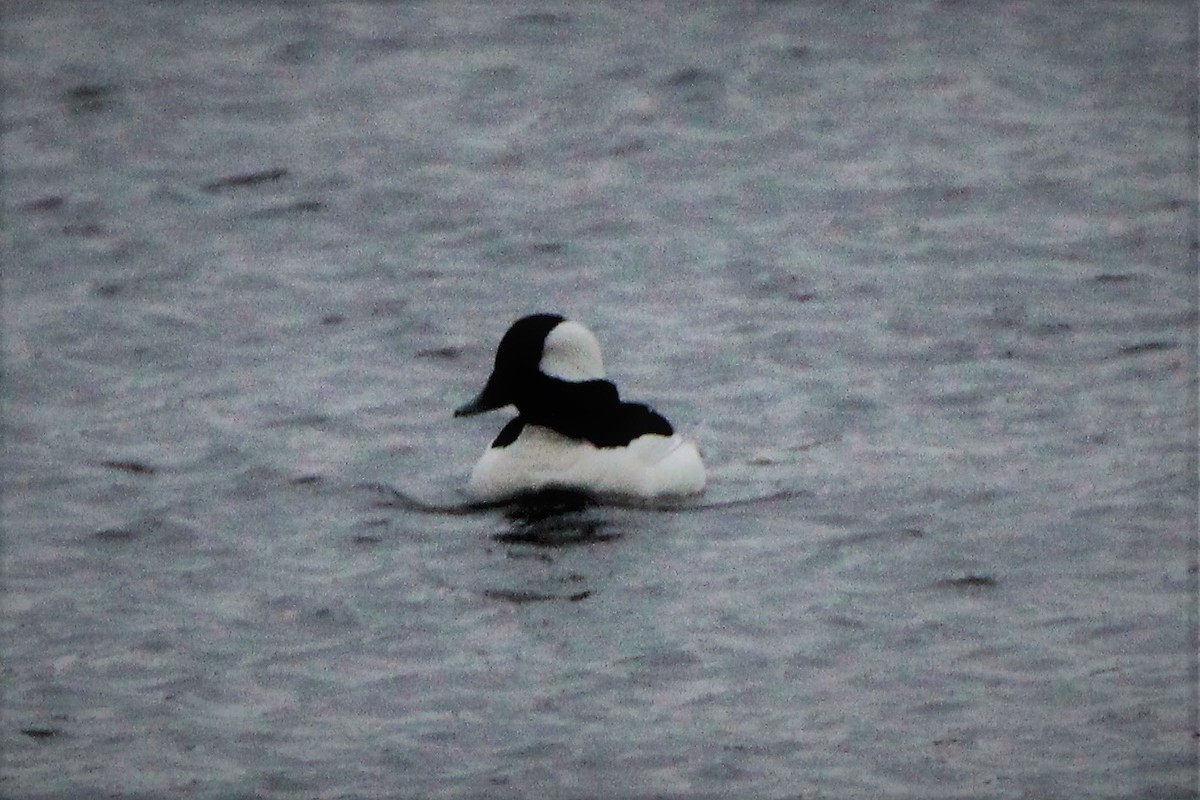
455 314 704 500
